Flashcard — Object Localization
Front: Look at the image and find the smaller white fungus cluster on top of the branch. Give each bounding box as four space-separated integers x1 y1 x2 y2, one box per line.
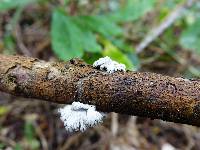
93 56 126 73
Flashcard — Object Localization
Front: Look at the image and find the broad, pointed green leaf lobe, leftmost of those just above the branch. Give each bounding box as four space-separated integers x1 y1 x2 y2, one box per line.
51 10 84 60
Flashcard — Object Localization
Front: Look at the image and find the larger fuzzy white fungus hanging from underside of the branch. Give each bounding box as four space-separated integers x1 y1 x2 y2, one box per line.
58 102 105 132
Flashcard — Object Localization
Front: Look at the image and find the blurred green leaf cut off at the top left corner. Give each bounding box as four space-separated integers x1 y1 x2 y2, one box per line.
0 0 36 11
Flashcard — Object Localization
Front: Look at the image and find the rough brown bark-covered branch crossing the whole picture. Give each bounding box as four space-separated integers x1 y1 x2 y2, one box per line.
0 55 200 126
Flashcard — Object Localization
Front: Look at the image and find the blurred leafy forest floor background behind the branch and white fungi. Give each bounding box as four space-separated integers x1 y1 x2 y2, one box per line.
0 0 200 150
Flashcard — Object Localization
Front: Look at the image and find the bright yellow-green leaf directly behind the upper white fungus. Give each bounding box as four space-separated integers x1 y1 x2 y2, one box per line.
102 39 133 70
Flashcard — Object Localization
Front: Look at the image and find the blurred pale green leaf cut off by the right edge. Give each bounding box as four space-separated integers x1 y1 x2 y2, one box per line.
180 19 200 55
